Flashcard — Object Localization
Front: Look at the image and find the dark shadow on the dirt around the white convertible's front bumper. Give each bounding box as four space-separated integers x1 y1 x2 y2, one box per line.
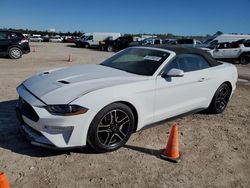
0 100 95 157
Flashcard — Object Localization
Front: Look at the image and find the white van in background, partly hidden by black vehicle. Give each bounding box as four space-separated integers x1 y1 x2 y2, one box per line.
75 32 121 48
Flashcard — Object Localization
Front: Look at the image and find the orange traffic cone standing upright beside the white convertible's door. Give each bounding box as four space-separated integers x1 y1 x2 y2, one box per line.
161 123 180 163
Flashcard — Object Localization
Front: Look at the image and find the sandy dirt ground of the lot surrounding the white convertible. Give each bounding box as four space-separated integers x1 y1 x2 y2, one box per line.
0 43 250 188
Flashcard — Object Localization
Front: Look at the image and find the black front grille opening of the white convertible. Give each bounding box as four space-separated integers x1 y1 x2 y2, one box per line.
18 97 39 122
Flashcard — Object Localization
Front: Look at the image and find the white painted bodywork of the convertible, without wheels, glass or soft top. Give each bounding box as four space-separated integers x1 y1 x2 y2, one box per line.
17 47 237 148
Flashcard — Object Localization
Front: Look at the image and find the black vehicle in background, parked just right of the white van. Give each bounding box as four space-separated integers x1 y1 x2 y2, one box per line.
99 36 133 52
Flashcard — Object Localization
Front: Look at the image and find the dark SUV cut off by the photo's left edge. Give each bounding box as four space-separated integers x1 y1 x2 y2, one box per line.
0 30 30 59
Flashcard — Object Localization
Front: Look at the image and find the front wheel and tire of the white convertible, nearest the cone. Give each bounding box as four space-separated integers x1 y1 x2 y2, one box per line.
88 103 135 152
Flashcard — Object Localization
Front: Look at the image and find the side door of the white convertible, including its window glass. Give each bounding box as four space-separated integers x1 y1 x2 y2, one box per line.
154 54 212 122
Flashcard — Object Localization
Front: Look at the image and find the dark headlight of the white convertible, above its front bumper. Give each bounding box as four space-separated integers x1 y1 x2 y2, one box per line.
45 104 88 116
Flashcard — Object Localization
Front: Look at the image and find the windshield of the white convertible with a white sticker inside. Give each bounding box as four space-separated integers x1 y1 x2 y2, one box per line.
101 48 169 76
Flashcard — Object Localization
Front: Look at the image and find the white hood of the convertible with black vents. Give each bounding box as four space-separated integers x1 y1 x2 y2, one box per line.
23 64 147 104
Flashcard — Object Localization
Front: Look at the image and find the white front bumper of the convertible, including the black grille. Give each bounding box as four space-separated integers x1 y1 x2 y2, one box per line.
16 85 95 148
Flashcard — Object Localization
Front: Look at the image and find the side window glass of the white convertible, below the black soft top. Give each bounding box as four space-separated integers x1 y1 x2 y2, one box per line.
164 54 210 73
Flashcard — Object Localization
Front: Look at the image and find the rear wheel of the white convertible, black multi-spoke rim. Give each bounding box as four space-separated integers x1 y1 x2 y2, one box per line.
208 83 231 114
